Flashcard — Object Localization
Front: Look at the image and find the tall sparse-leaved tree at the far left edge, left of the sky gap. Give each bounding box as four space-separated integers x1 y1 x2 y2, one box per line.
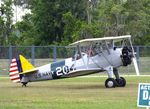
0 0 13 45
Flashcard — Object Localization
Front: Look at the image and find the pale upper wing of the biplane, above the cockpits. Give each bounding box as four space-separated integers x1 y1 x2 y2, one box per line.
69 35 131 46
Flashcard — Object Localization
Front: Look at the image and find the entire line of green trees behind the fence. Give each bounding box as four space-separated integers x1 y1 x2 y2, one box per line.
0 0 150 45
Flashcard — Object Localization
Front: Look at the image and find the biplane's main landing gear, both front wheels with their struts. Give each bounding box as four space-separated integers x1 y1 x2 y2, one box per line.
105 66 126 88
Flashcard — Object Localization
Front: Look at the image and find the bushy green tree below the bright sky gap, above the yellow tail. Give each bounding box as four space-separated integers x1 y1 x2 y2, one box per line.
11 14 36 45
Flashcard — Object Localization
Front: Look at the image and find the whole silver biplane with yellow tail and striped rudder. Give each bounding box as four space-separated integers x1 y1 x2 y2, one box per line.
9 35 139 88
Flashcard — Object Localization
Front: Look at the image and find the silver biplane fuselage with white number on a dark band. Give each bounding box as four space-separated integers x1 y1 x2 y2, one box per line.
21 48 123 82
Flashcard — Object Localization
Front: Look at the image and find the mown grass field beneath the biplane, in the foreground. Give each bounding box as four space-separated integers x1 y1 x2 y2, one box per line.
0 77 150 109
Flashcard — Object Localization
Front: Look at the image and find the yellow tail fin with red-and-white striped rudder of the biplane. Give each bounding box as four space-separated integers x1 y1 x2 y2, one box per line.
9 55 34 83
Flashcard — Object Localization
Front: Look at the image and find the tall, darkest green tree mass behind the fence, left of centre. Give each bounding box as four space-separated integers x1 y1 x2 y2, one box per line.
32 0 89 45
